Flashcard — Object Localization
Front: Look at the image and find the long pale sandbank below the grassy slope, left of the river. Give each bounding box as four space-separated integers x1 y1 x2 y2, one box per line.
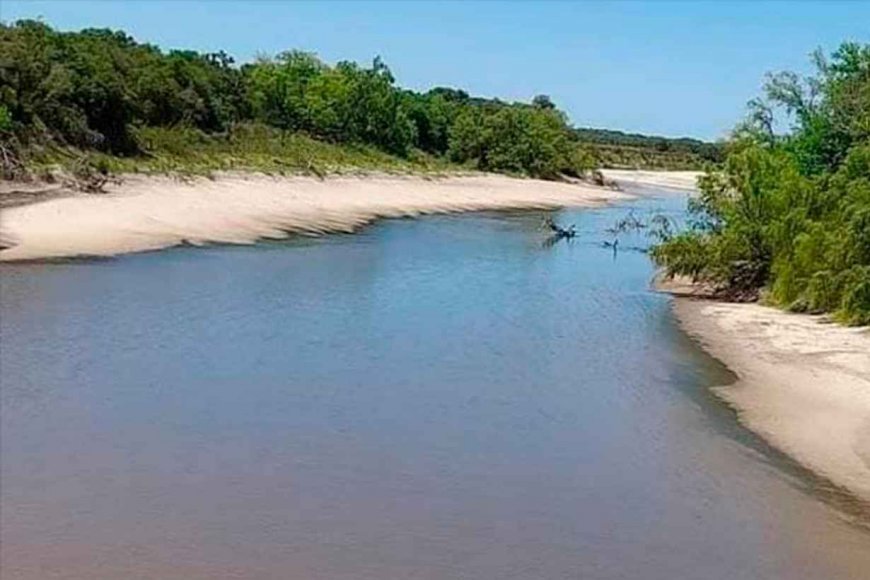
0 175 628 260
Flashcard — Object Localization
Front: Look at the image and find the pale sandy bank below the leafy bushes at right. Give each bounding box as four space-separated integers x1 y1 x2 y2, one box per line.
675 297 870 501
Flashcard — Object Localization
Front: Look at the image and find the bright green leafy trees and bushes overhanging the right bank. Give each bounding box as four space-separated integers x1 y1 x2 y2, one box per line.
654 43 870 324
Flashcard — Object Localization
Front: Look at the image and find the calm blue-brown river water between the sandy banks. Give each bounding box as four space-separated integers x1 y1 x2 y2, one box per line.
0 196 870 580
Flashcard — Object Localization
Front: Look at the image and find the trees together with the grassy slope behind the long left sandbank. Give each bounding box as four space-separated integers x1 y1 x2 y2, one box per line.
0 20 714 179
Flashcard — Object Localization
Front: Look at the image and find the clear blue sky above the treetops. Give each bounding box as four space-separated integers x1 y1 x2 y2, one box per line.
0 0 870 139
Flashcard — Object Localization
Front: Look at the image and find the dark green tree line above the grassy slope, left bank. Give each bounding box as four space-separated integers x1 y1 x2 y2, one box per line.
0 20 608 178
